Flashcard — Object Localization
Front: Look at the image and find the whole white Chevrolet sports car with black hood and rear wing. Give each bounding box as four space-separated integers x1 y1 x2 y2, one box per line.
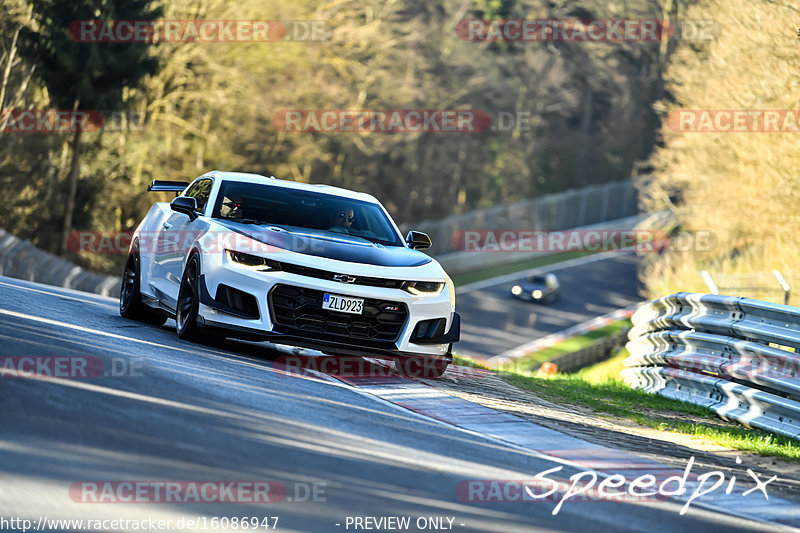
120 171 461 376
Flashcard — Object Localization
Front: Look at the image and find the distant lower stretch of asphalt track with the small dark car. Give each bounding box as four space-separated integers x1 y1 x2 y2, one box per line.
456 254 642 356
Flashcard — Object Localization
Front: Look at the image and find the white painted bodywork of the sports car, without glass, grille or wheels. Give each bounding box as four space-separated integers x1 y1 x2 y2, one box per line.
131 171 460 357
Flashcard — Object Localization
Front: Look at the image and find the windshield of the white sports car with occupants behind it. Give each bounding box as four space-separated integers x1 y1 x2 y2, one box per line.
211 181 405 246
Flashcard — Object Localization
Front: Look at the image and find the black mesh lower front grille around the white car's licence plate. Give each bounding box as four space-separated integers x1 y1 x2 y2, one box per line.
268 284 408 342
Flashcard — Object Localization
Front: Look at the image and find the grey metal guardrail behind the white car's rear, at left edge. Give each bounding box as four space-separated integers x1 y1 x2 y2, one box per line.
0 229 122 297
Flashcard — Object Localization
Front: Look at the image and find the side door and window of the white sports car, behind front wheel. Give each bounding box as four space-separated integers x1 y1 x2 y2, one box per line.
157 178 214 309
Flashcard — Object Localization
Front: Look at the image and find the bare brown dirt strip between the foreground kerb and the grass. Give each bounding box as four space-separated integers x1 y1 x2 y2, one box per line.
421 366 800 501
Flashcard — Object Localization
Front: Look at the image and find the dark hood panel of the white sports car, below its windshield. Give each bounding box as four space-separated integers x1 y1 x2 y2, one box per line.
215 219 431 267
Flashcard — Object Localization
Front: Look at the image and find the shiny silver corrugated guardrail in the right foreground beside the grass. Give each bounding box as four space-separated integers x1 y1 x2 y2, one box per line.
622 292 800 439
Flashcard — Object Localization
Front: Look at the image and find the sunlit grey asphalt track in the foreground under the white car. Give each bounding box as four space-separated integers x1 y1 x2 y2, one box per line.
0 274 792 533
